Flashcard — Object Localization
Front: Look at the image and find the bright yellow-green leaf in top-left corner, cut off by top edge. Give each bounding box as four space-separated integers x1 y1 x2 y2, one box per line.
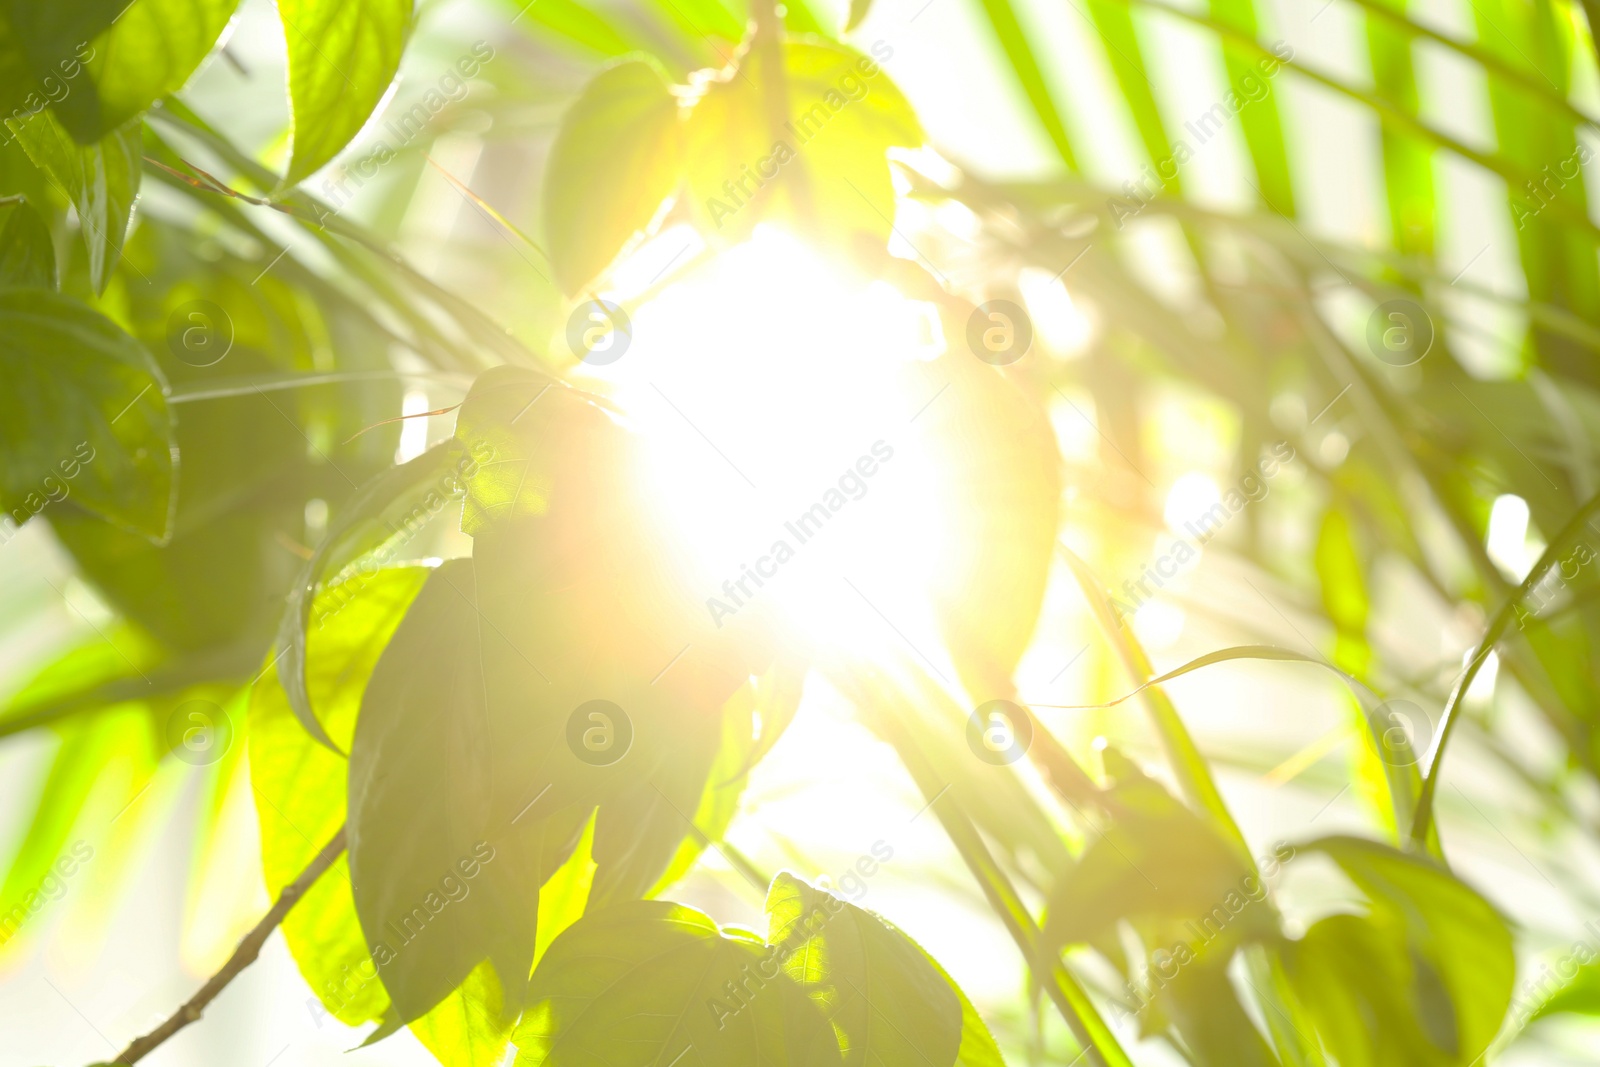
54 0 238 144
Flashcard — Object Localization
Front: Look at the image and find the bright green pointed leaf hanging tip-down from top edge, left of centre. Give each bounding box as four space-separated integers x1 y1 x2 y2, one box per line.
278 0 413 187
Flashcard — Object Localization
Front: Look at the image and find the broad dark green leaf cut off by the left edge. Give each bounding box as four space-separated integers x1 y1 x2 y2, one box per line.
0 290 173 539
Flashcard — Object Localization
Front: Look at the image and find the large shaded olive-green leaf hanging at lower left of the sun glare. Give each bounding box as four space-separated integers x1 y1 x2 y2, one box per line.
347 560 598 1022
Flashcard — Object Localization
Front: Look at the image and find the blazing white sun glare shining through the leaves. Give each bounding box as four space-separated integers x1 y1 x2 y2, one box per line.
582 224 949 646
